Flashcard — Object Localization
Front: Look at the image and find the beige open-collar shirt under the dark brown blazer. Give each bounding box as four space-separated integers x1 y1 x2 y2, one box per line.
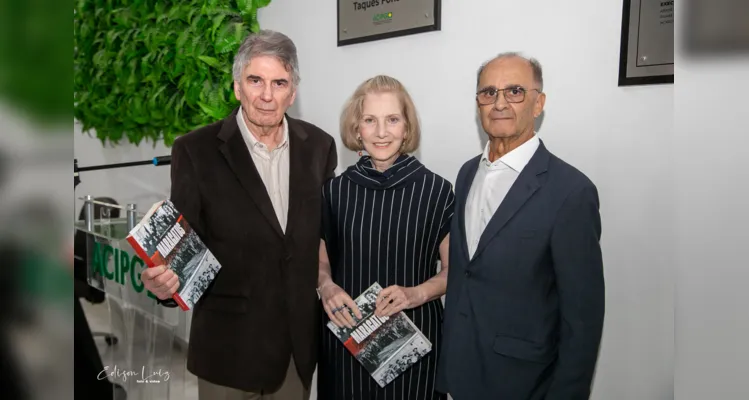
237 106 289 232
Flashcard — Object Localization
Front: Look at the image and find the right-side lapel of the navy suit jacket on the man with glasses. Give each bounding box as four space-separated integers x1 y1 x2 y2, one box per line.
472 142 549 259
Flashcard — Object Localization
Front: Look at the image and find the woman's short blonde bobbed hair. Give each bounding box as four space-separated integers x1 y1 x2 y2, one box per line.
340 75 421 153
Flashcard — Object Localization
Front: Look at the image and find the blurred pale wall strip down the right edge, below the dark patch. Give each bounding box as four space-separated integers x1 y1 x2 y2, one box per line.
674 28 749 400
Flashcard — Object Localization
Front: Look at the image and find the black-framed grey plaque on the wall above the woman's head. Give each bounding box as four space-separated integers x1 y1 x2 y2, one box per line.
338 0 441 46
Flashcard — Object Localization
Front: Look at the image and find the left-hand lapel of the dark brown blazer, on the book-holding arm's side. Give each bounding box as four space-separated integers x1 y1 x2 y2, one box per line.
218 108 283 236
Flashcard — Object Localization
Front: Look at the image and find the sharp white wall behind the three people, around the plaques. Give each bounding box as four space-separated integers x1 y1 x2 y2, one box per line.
259 0 674 400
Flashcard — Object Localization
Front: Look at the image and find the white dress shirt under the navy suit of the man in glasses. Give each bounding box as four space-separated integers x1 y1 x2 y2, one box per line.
465 134 539 258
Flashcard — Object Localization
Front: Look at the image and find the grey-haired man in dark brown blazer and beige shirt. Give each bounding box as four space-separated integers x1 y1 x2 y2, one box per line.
142 31 337 400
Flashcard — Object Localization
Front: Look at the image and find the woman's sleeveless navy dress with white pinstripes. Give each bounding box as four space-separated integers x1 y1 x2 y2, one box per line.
317 155 454 400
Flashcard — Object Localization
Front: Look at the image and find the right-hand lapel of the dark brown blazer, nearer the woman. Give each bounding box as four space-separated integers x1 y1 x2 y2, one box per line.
286 116 312 236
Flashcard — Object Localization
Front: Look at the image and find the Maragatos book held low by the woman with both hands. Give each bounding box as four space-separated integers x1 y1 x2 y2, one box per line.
328 283 432 387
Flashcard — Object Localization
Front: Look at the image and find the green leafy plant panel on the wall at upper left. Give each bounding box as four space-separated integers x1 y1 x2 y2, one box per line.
74 0 270 146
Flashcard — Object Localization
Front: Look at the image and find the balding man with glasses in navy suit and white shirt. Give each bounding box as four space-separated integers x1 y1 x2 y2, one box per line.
437 53 605 400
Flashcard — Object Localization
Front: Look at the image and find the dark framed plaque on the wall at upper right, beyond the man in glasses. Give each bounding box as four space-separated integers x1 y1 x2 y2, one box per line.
619 0 674 86
